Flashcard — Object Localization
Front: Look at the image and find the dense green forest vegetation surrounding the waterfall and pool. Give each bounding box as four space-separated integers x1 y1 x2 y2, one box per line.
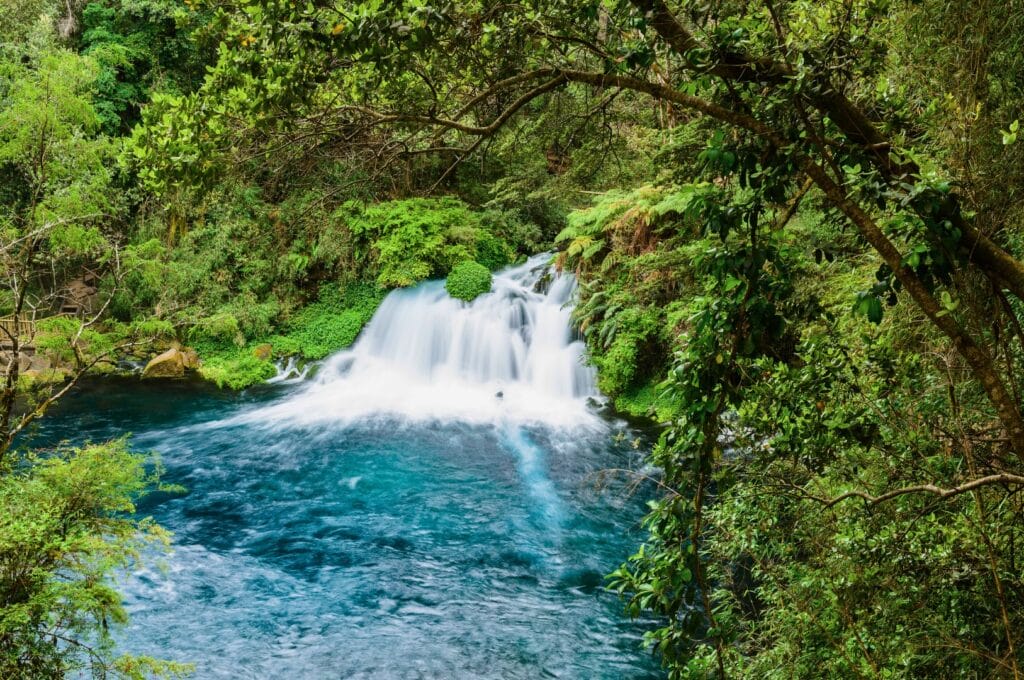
0 0 1024 678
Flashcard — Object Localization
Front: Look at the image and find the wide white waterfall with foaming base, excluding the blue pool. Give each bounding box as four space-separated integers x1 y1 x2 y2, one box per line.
232 255 600 427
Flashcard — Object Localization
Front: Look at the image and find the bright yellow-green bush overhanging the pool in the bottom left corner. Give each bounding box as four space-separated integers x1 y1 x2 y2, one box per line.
0 440 188 679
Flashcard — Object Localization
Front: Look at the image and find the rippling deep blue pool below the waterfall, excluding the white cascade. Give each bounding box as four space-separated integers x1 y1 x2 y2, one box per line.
35 381 658 678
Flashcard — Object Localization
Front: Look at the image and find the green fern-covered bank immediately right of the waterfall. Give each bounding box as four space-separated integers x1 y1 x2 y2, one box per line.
556 185 707 405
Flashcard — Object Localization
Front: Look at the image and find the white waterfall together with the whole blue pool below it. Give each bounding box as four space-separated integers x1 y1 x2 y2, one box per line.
36 256 655 680
